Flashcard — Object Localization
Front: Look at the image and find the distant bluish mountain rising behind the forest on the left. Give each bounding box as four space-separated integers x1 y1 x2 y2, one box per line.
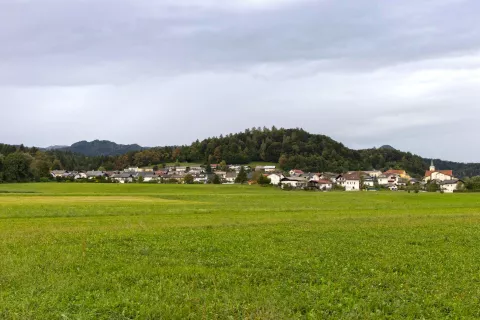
62 140 147 157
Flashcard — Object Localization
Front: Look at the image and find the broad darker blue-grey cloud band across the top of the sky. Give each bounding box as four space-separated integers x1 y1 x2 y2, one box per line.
0 0 480 85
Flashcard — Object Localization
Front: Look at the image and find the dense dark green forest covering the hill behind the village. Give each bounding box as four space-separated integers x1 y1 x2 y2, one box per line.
0 127 480 182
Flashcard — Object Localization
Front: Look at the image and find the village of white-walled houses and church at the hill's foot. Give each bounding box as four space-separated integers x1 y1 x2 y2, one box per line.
51 161 463 193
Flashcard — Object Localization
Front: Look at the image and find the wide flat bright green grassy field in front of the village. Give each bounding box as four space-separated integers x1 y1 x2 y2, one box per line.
0 183 480 319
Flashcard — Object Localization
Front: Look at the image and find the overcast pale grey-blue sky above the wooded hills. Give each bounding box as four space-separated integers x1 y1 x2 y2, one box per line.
0 0 480 162
